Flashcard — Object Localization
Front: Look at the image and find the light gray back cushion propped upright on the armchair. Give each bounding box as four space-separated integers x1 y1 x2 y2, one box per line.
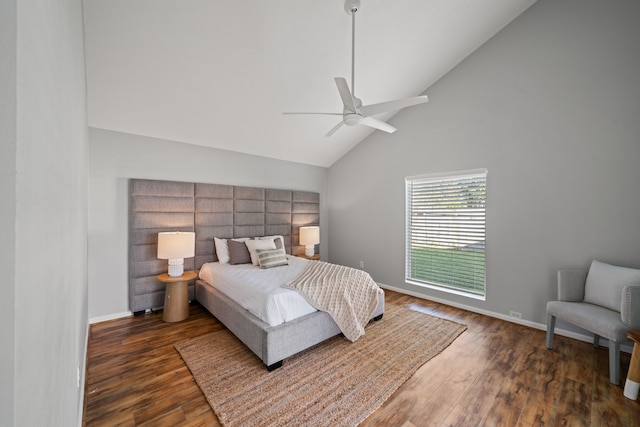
584 260 640 312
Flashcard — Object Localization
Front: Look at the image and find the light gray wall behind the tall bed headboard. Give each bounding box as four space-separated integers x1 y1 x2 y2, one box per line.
89 128 328 322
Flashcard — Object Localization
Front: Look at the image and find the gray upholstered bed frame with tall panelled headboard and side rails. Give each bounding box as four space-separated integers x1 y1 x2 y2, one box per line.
129 179 384 369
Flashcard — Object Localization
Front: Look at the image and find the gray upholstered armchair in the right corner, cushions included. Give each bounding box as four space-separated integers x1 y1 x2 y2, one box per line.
546 260 640 385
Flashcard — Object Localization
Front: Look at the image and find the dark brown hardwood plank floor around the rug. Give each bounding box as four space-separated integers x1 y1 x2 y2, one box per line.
83 291 640 427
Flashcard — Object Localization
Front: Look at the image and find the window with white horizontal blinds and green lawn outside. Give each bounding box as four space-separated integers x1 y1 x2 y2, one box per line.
405 169 487 299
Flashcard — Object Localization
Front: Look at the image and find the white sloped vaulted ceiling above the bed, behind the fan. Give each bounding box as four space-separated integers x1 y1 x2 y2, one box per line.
84 0 535 167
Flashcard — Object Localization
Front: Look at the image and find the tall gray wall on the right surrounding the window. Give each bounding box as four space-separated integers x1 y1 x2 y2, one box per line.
329 0 640 323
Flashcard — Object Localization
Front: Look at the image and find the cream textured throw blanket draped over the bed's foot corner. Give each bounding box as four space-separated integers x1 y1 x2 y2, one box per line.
282 261 382 342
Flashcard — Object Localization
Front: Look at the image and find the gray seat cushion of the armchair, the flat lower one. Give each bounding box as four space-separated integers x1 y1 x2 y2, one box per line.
547 301 629 342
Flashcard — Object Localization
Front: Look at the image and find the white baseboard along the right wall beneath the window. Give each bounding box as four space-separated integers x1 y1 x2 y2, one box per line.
378 283 633 353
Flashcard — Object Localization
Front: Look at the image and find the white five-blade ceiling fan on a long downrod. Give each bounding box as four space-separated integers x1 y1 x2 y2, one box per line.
282 0 429 136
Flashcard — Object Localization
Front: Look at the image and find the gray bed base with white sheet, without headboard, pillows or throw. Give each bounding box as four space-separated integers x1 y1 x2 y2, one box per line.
196 244 384 370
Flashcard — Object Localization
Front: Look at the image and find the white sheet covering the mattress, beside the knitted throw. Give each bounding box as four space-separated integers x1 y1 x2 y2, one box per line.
200 256 317 326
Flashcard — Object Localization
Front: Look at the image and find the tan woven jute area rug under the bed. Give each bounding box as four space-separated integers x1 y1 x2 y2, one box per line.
176 304 466 427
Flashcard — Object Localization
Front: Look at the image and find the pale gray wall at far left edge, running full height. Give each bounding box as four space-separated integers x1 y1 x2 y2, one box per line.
0 0 88 426
